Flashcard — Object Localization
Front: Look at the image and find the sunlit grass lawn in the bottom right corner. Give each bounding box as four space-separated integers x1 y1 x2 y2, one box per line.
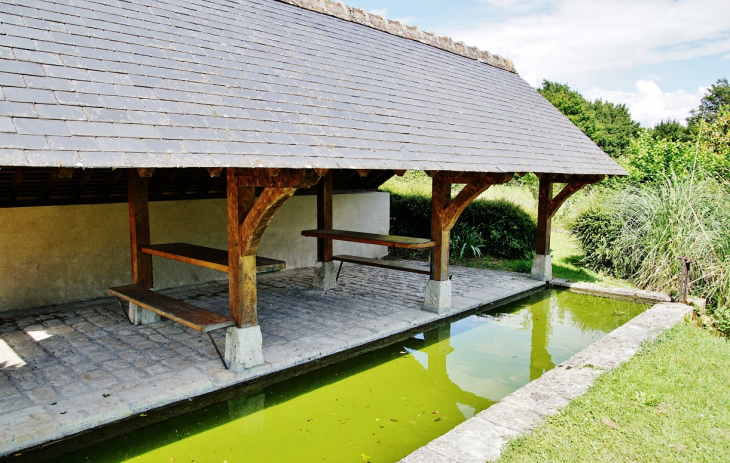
500 324 730 462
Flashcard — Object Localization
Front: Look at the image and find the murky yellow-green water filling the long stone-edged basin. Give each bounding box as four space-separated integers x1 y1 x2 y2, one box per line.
58 290 647 463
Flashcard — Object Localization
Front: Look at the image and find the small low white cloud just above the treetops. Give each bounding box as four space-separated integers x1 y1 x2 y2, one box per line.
583 80 707 127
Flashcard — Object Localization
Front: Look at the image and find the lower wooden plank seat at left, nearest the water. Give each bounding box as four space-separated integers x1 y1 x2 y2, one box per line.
109 285 234 333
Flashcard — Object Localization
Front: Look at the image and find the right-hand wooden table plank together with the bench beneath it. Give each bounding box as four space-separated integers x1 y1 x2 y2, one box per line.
302 229 436 280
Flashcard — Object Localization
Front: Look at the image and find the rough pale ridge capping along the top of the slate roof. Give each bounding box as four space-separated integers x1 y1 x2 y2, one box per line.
279 0 517 73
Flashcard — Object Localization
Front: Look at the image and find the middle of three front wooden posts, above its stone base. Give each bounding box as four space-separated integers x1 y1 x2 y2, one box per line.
431 175 451 281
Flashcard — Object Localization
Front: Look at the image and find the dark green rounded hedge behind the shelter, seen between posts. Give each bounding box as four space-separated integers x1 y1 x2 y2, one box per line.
390 192 537 259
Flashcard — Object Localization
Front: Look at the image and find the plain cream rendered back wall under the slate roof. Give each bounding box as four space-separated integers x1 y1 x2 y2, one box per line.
0 192 390 312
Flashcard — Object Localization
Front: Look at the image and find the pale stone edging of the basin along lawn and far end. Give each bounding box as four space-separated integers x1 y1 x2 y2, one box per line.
401 279 705 463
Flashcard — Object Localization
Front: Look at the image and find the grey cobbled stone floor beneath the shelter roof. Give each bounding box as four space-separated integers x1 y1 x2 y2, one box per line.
0 264 544 461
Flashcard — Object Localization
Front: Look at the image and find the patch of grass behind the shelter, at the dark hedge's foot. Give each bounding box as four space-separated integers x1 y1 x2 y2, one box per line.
451 230 629 286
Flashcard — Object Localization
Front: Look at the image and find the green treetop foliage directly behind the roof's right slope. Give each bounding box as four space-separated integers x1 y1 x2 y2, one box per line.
538 80 639 158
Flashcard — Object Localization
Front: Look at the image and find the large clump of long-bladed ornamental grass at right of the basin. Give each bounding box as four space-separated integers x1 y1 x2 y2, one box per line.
571 176 730 334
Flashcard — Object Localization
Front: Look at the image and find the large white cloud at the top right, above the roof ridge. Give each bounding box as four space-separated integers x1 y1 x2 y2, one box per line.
438 0 730 86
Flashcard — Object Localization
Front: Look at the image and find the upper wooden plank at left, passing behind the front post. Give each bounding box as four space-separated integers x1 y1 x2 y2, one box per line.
142 243 286 273
